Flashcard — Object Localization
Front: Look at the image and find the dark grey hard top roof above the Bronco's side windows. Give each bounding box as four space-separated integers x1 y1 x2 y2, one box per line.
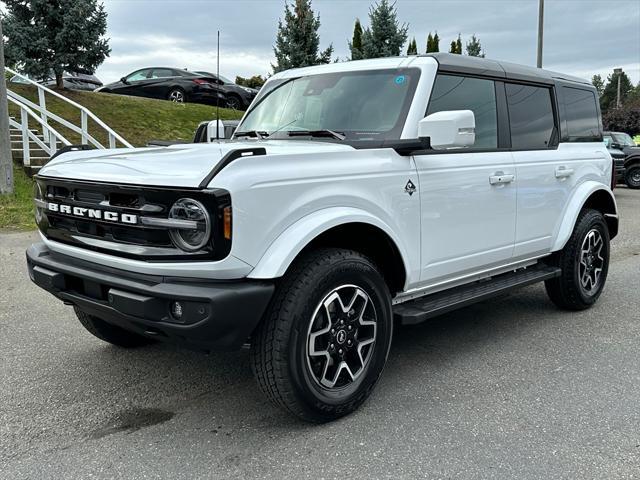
420 53 591 86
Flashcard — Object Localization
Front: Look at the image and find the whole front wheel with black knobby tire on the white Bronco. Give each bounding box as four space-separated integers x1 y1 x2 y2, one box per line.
251 249 393 423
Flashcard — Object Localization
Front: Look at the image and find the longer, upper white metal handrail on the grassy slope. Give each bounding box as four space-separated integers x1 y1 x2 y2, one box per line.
5 67 133 148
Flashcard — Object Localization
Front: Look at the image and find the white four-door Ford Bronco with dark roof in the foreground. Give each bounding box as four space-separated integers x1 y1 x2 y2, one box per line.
27 54 618 422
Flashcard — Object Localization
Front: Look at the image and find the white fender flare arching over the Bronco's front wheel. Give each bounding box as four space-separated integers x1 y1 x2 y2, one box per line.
248 207 409 293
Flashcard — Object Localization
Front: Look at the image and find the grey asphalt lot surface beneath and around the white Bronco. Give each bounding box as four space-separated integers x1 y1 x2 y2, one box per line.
0 188 640 479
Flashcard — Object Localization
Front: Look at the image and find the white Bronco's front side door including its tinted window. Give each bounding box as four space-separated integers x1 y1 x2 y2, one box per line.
415 74 517 285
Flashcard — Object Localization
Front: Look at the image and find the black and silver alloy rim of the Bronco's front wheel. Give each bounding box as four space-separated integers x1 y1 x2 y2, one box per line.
307 285 377 390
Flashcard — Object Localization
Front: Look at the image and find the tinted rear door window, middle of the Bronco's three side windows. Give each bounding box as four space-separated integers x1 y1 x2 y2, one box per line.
505 83 554 150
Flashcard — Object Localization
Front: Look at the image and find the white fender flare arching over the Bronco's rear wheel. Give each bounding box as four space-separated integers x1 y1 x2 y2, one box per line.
551 182 618 252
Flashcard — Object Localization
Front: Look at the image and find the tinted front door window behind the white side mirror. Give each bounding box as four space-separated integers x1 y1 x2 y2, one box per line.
427 75 498 148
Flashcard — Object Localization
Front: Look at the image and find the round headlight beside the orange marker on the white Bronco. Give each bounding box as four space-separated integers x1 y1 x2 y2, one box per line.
169 198 211 252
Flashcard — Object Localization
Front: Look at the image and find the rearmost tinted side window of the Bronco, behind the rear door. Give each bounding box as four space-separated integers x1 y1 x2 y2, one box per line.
562 87 600 142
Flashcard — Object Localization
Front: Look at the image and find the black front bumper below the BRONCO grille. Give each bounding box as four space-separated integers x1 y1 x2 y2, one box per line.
27 243 275 351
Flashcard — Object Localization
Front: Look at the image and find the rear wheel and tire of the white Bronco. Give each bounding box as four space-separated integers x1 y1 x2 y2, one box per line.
545 209 609 310
